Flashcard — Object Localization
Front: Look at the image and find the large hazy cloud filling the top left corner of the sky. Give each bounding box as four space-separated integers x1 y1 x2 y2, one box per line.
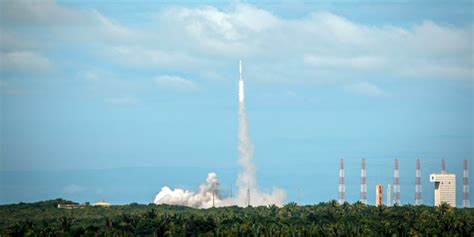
0 0 140 53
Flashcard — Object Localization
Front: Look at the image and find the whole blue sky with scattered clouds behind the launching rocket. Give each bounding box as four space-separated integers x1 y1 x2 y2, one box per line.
0 0 474 204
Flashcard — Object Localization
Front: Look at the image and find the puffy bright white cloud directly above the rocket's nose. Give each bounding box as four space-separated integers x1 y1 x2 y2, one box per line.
154 4 264 58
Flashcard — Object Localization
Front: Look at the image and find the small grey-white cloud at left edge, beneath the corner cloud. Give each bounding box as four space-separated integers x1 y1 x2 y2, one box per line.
0 51 52 72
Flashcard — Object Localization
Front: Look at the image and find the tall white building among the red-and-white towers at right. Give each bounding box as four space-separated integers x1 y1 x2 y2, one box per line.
430 173 456 207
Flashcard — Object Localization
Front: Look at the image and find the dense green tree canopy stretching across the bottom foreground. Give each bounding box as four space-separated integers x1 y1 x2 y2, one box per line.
0 199 474 236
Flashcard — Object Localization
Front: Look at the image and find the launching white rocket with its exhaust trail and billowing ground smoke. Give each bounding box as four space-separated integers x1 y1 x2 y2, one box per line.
154 61 286 208
